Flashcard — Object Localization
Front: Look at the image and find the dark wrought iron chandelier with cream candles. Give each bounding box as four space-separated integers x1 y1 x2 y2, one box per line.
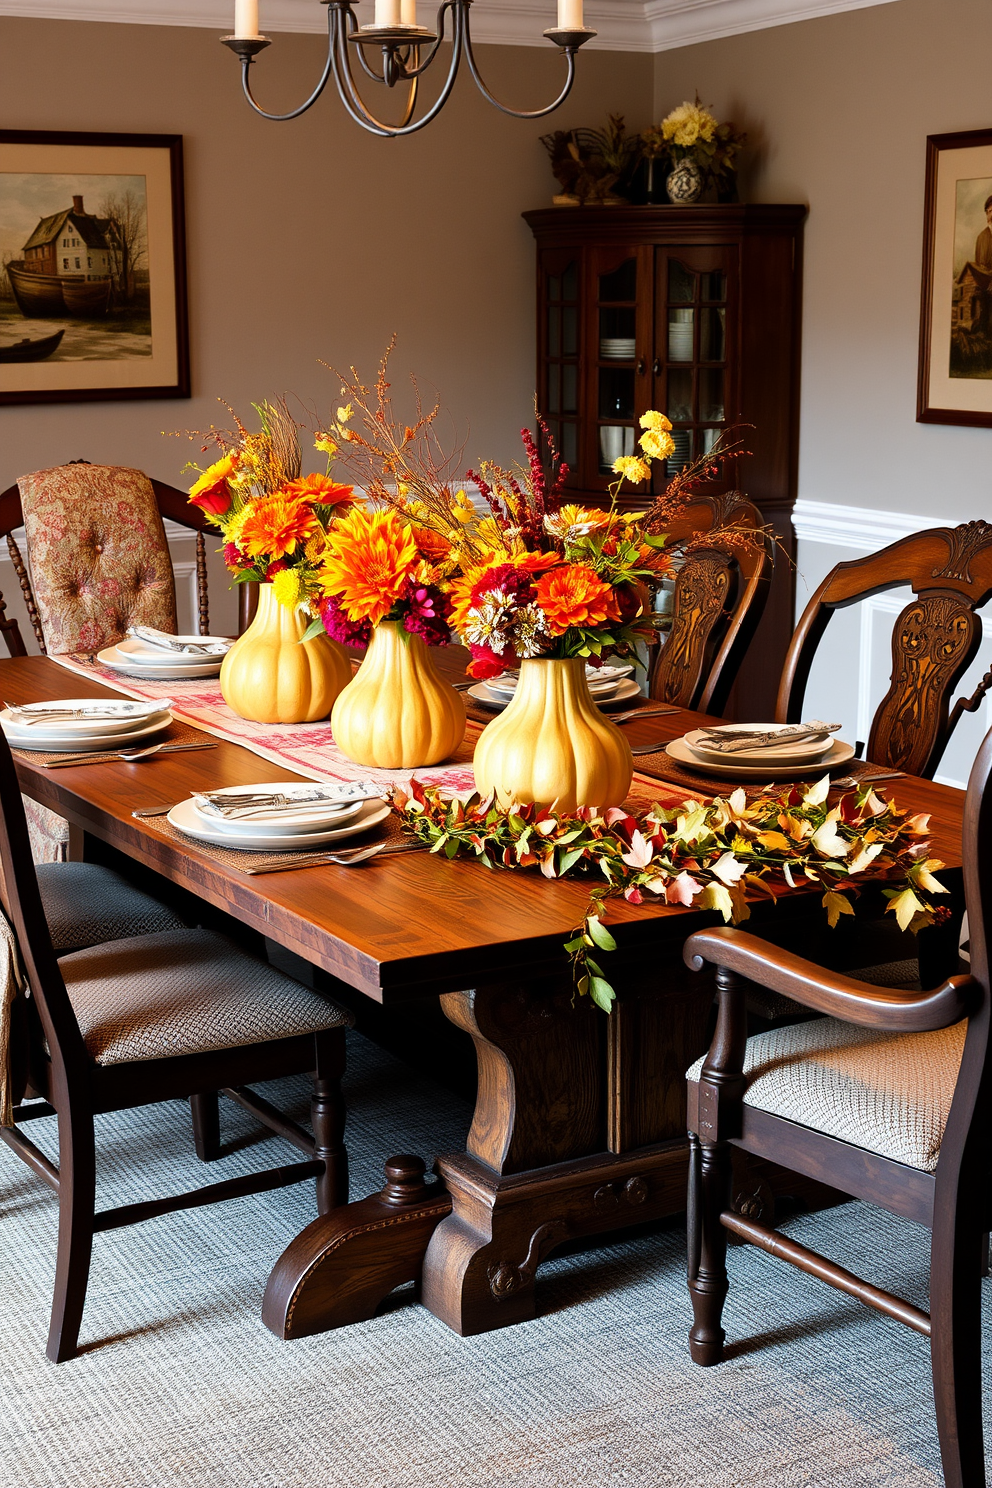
222 0 596 137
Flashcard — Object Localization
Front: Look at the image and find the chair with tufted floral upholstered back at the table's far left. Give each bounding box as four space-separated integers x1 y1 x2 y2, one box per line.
0 460 210 863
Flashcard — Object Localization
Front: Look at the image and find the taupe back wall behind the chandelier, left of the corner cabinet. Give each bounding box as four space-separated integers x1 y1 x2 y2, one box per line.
0 18 653 490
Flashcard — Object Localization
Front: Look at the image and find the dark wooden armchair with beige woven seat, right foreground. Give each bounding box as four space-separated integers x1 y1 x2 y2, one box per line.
684 714 992 1488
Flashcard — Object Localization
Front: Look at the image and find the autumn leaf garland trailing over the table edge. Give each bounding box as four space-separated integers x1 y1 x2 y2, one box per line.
393 777 947 1012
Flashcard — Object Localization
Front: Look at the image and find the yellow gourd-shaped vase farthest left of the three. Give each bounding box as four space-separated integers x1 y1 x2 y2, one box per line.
220 583 351 723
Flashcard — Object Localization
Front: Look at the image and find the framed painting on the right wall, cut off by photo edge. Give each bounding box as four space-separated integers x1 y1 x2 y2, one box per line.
916 129 992 427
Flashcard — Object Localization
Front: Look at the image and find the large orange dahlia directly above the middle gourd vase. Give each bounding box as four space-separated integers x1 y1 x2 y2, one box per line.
320 506 418 625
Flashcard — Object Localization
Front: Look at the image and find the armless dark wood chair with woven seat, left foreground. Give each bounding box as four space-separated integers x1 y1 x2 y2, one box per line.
0 737 352 1363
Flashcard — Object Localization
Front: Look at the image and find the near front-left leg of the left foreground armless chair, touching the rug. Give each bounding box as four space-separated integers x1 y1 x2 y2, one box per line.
46 1112 97 1364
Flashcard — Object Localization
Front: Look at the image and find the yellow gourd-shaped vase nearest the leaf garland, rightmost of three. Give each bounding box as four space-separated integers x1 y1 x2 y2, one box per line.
473 658 634 811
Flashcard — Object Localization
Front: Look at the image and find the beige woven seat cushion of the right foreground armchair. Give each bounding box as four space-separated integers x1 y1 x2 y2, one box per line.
687 1018 967 1173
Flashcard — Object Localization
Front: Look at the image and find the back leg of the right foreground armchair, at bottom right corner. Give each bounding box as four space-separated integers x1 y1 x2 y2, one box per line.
930 1207 986 1488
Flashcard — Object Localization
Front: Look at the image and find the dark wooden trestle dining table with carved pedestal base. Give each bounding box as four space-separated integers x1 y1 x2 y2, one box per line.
0 647 964 1336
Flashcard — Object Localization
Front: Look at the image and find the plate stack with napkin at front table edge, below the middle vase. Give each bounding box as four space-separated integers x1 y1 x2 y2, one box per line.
168 780 390 853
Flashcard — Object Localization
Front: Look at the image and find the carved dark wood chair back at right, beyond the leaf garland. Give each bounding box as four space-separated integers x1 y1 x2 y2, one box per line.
776 521 992 777
